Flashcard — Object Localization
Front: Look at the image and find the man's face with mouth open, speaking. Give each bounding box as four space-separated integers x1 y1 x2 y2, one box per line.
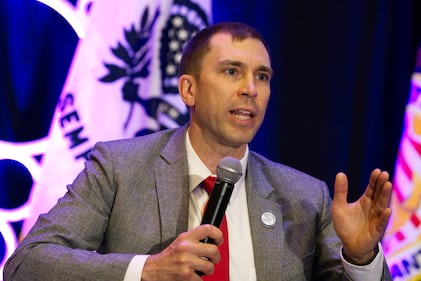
185 33 272 151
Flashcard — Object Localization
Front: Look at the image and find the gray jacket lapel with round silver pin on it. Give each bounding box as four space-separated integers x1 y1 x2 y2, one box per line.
246 154 284 280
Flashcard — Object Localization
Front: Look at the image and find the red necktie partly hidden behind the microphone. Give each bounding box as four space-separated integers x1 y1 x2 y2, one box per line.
202 176 229 281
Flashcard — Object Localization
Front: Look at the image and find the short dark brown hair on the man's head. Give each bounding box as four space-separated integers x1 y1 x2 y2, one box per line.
178 22 270 78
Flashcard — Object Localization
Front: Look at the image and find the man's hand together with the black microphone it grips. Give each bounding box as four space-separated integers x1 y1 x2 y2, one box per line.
142 157 242 280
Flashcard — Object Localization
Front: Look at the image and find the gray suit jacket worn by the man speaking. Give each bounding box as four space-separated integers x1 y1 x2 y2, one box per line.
4 126 391 281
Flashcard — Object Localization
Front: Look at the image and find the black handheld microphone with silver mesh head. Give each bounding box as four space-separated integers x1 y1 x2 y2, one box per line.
201 157 243 244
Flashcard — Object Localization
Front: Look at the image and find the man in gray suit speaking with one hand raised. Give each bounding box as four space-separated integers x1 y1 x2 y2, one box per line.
4 23 392 281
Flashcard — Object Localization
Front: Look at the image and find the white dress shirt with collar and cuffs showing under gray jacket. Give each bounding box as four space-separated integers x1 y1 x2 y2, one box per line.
124 130 384 281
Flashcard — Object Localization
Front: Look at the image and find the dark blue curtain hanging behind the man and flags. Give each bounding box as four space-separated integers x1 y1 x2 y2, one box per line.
0 0 421 203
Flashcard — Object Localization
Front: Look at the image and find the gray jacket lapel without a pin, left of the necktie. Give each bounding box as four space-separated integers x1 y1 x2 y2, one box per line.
154 126 189 248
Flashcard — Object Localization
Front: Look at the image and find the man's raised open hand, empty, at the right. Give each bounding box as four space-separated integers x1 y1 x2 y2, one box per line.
332 169 392 264
